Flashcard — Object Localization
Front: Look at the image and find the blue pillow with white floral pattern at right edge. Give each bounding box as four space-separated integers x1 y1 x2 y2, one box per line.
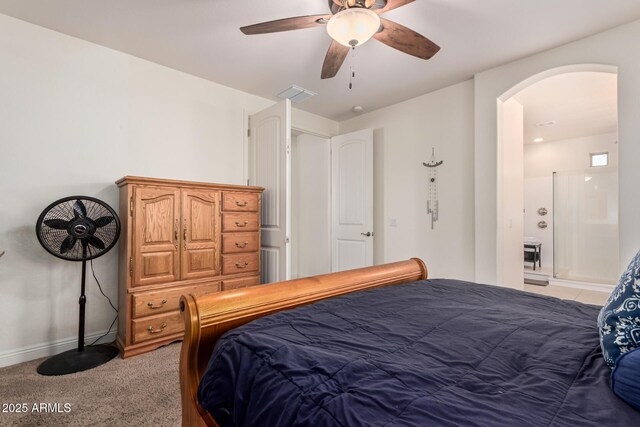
598 252 640 367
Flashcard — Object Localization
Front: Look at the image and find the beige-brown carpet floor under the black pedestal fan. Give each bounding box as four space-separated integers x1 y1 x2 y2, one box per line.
0 343 181 427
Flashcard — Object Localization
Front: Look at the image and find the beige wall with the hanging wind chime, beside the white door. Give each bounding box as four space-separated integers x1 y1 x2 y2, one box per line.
340 81 474 280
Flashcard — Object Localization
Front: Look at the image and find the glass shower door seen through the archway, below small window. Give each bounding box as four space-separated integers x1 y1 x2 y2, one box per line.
553 168 619 284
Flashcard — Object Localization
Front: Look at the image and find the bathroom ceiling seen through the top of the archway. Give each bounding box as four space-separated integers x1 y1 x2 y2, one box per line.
514 72 618 144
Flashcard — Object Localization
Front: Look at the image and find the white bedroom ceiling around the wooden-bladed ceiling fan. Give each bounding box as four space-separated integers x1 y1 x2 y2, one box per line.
0 0 640 120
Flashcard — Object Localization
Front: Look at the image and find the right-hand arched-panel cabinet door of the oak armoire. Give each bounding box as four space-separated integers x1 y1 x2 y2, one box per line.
181 189 220 280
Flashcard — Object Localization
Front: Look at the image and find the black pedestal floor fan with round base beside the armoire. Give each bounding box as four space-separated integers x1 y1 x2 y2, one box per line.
36 196 120 375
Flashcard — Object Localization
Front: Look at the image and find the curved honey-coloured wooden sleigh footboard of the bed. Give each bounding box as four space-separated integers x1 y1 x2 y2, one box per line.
180 258 428 427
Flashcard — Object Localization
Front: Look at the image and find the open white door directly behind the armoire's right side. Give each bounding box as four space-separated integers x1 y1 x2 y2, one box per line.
249 99 291 283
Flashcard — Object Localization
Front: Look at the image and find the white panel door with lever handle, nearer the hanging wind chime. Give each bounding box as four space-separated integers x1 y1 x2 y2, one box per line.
331 129 374 271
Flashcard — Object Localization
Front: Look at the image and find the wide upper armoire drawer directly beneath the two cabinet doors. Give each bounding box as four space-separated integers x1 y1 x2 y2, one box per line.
132 282 221 318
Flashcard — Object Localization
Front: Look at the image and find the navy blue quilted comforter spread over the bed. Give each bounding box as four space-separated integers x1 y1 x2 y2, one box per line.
199 279 640 427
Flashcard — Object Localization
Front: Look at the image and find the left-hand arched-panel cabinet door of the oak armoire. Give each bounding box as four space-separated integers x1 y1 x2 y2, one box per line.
133 187 180 286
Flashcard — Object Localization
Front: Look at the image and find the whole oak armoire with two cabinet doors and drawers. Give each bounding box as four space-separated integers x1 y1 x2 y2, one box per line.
116 176 264 357
